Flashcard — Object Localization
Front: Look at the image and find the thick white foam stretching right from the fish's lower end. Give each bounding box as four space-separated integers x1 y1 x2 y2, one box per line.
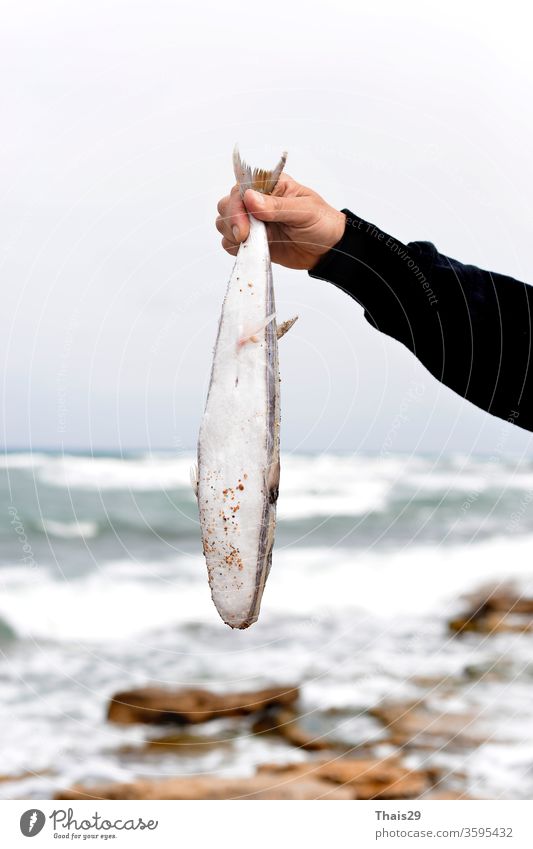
265 537 533 617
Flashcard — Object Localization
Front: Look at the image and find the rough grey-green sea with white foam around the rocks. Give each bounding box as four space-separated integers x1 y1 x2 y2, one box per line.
0 451 533 798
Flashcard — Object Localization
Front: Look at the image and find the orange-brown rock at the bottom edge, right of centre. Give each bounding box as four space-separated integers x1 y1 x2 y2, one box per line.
258 758 431 799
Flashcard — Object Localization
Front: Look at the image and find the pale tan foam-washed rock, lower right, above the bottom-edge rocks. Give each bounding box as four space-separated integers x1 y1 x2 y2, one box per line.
369 702 489 751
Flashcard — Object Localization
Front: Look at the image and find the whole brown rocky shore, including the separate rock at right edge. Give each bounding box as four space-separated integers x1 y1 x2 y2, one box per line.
50 586 533 800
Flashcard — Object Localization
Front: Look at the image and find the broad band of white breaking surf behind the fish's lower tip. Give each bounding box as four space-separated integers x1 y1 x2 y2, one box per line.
0 536 533 642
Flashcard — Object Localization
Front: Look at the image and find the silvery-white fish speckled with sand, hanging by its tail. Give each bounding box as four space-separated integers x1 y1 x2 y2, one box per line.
191 146 297 629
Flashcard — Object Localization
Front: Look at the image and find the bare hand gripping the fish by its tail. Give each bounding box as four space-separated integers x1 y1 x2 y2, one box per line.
216 174 346 269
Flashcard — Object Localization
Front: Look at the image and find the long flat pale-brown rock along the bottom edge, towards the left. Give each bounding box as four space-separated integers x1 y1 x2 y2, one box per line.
54 773 354 800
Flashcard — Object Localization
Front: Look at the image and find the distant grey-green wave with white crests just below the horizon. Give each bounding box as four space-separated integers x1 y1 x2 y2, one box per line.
0 452 533 546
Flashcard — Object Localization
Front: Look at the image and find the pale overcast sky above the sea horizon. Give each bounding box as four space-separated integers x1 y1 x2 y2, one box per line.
0 0 533 453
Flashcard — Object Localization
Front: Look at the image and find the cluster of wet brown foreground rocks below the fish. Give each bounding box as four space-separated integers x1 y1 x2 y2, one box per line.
56 672 465 800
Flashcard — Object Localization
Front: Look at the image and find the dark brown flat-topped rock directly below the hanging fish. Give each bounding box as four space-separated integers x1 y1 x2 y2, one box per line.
107 687 299 725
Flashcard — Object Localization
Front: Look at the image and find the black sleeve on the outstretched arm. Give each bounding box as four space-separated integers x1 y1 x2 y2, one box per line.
309 209 533 430
